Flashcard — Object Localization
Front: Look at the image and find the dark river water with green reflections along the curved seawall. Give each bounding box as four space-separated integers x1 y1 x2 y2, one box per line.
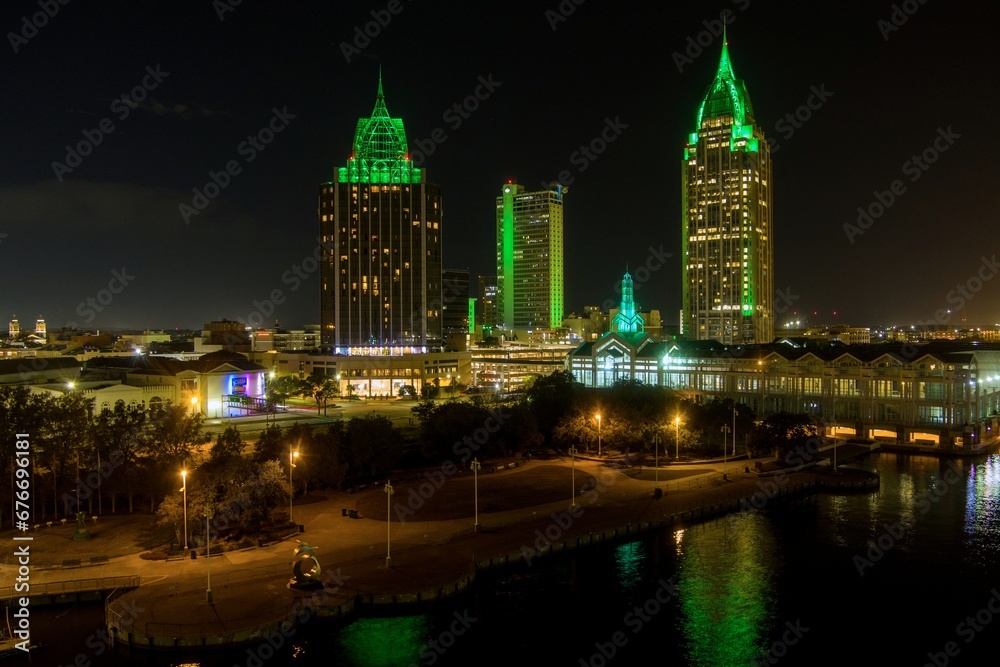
8 453 1000 667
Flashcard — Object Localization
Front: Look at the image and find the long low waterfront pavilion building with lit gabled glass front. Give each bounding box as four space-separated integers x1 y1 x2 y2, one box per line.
566 332 1000 451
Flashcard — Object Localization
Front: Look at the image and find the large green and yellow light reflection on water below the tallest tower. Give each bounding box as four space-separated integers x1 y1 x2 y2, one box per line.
677 513 777 667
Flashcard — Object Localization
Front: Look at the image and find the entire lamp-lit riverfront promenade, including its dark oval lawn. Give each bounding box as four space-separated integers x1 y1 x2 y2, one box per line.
0 445 877 648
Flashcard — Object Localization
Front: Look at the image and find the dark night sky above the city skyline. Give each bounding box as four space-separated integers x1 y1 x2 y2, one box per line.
0 0 1000 330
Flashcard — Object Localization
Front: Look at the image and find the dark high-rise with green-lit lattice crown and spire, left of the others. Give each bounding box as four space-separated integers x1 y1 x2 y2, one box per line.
319 76 442 352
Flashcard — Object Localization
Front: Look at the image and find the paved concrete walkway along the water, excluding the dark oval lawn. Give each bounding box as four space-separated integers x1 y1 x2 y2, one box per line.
0 446 876 646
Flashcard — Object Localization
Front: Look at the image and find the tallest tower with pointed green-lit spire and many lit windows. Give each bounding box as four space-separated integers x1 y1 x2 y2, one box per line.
681 32 774 344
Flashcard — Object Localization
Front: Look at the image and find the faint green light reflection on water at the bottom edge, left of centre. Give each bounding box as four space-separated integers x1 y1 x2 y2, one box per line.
340 615 430 667
